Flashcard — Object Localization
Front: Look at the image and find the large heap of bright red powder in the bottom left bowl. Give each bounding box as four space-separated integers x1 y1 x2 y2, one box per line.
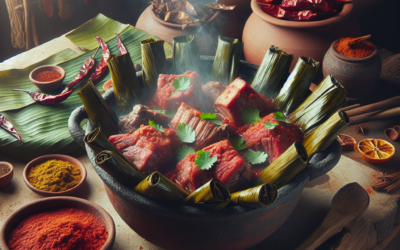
7 208 108 250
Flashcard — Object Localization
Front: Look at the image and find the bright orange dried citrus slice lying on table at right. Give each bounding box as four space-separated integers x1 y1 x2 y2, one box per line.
357 139 394 163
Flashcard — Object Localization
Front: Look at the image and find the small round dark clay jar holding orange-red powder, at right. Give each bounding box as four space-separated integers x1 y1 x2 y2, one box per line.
322 40 382 100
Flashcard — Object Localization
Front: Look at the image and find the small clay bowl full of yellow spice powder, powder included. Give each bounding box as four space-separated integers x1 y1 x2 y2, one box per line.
24 154 86 196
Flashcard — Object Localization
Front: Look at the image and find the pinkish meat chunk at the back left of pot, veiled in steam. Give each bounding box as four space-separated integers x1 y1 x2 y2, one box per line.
154 71 202 111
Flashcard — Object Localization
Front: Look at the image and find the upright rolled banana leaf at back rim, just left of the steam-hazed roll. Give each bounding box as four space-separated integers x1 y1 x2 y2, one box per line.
141 38 168 91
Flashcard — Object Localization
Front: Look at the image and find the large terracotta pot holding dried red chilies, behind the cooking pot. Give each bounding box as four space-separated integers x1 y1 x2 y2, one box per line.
243 0 361 81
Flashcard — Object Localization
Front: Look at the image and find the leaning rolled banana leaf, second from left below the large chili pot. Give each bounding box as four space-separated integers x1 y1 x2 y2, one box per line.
275 57 320 115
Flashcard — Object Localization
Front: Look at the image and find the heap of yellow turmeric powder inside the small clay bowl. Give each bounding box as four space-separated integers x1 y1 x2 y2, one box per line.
28 160 82 192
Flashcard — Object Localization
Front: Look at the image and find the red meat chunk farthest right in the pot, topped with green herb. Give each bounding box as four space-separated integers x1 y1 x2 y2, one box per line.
242 113 303 163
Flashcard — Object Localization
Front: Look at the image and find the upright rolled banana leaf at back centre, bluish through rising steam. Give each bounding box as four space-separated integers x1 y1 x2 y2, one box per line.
172 35 201 74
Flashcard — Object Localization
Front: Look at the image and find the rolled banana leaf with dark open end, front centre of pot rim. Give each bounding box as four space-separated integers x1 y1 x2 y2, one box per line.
185 179 231 210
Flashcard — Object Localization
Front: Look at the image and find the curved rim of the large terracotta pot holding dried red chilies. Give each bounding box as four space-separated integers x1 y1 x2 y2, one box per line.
251 0 353 29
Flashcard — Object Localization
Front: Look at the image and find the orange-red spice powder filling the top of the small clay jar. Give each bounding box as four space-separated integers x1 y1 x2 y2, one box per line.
333 37 375 58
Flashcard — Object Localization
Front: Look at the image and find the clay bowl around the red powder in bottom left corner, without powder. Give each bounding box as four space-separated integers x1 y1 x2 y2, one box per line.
0 197 115 250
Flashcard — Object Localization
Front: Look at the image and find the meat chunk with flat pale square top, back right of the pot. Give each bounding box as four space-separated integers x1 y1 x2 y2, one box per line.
215 78 274 127
